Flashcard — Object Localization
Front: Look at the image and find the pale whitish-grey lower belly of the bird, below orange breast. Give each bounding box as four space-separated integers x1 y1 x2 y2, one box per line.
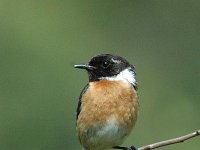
83 116 128 150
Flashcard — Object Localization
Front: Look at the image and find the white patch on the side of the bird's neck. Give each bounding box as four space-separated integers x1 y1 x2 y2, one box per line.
100 68 136 86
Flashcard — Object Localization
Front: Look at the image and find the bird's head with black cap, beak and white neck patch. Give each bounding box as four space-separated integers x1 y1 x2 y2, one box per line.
75 54 136 85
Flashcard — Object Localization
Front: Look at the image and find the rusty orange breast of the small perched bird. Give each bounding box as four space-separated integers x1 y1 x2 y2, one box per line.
77 80 138 134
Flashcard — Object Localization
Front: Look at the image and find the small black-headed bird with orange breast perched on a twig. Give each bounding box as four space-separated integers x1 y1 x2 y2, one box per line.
74 54 139 150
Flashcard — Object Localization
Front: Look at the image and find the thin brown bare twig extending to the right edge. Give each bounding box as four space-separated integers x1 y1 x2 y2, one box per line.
138 130 200 150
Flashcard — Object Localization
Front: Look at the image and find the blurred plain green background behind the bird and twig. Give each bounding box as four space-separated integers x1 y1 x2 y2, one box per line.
0 0 200 150
